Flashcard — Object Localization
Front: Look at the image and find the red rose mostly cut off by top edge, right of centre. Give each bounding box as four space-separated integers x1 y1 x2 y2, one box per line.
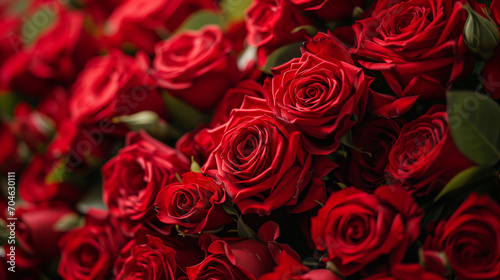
290 0 365 21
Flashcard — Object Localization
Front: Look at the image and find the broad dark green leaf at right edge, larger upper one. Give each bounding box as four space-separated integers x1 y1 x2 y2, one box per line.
447 91 500 166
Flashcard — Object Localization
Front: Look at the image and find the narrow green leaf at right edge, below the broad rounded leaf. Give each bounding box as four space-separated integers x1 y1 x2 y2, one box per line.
434 166 496 202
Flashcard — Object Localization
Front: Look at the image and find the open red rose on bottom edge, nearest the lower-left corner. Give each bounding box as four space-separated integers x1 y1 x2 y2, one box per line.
58 210 126 280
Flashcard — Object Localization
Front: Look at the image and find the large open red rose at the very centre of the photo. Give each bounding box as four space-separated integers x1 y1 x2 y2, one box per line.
202 97 334 216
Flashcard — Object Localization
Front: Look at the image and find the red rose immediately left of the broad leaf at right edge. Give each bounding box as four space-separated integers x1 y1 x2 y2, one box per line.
386 106 474 196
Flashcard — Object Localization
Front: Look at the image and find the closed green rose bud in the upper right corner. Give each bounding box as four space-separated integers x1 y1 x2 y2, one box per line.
464 5 499 60
